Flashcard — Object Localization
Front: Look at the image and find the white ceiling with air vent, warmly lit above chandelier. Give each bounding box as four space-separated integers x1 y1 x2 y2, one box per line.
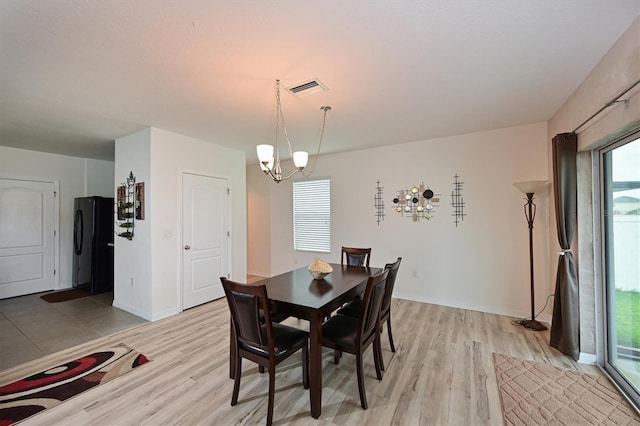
0 0 640 163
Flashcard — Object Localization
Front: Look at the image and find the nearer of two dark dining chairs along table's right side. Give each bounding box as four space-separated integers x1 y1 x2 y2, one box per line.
322 269 389 410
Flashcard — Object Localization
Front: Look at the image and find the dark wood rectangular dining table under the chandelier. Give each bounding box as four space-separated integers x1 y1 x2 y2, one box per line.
230 263 382 419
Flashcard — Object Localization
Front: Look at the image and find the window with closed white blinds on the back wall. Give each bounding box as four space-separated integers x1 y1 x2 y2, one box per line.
293 179 331 253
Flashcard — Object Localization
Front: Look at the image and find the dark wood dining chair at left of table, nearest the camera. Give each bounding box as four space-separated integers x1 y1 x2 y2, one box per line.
220 277 309 425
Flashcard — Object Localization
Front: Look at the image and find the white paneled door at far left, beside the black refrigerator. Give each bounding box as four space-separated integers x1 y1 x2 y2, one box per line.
0 179 55 299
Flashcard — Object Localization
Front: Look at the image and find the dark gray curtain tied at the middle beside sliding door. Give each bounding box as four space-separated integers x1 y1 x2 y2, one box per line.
550 133 580 361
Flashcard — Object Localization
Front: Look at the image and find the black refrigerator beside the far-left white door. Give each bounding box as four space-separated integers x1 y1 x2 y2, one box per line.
72 196 114 294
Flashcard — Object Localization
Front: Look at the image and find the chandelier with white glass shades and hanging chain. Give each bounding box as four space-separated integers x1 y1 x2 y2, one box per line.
256 80 331 183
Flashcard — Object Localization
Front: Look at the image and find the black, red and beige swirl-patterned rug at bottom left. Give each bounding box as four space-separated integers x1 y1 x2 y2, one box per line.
0 344 150 426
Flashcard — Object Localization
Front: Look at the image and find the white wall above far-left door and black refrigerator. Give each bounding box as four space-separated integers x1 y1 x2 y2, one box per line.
0 146 114 289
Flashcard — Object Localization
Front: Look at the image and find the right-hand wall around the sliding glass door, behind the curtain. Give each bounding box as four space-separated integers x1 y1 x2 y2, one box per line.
547 19 640 354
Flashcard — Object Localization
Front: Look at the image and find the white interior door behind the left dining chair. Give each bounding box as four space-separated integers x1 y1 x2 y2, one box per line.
182 173 229 309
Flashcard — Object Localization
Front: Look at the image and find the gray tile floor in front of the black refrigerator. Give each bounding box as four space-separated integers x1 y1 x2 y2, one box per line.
0 293 147 371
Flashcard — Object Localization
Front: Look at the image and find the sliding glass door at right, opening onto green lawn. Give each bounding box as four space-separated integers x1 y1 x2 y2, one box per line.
600 133 640 406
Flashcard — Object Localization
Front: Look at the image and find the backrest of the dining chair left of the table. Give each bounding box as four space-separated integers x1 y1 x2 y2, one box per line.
220 277 273 356
